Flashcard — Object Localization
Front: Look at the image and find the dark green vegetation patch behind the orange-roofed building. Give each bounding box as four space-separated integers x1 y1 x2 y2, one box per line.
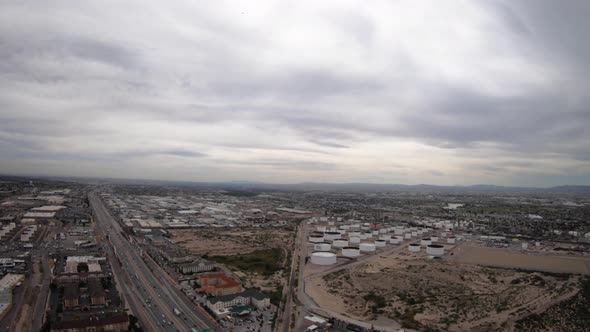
209 248 283 276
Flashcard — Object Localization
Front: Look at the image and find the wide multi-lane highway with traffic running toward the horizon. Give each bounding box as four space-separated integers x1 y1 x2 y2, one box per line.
88 193 220 331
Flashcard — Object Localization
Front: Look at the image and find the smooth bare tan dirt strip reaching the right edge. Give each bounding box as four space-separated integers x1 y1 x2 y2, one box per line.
445 243 590 274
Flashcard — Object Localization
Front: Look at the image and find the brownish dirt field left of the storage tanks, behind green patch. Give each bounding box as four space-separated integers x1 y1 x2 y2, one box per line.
171 228 295 256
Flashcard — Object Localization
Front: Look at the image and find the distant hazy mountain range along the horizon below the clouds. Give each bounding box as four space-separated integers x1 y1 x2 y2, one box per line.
0 176 590 195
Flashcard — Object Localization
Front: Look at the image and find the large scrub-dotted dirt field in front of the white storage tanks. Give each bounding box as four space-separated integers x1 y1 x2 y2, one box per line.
306 252 580 331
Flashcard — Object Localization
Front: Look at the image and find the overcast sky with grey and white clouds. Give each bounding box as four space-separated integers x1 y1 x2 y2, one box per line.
0 0 590 186
